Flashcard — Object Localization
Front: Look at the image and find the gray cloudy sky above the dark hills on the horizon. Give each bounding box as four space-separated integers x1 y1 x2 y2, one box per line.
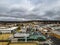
0 0 60 21
